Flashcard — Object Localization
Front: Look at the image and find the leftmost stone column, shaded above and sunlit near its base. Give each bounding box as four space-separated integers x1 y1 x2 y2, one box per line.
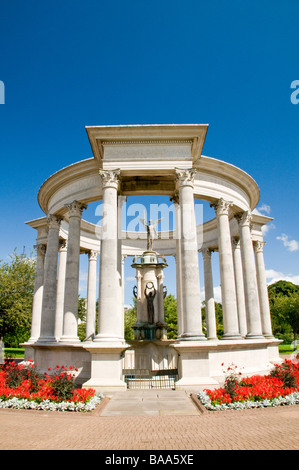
28 244 46 343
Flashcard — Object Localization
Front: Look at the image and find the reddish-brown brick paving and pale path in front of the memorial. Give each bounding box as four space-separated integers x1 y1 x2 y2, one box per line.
0 391 299 455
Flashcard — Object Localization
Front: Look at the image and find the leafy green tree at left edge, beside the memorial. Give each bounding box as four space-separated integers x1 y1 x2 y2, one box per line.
0 249 36 347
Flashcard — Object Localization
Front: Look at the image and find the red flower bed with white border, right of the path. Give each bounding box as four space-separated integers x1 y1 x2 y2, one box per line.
198 360 299 411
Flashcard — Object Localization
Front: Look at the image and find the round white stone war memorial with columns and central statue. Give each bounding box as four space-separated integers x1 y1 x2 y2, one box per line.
25 124 280 392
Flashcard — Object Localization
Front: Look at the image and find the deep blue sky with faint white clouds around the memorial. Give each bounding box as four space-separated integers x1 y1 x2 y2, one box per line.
0 0 299 303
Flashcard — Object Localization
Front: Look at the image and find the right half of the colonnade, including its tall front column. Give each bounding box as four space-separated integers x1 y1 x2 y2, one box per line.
176 170 273 340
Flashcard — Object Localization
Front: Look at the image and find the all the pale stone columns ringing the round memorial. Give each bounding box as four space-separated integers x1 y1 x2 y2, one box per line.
29 169 273 344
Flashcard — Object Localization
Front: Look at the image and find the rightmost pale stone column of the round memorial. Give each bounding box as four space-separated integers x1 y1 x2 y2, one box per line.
253 240 273 339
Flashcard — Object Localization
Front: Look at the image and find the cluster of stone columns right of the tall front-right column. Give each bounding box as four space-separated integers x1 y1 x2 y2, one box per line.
201 206 273 340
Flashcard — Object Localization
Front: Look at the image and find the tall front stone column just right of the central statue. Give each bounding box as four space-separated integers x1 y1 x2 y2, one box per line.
176 169 206 340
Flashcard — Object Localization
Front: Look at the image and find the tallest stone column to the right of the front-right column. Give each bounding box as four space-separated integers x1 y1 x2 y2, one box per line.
210 198 241 339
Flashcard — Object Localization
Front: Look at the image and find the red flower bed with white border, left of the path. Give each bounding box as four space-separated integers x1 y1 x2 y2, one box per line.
0 361 103 411
